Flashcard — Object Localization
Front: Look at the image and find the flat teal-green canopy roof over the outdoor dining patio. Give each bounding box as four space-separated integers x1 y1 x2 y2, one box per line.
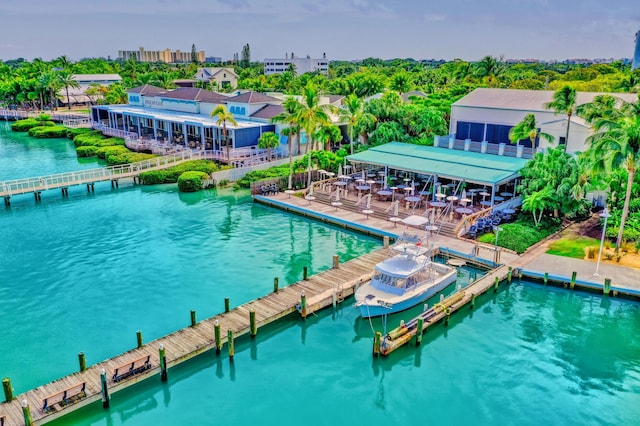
347 142 528 185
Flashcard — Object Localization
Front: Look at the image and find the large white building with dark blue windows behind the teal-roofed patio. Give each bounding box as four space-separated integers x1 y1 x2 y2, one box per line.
449 88 638 152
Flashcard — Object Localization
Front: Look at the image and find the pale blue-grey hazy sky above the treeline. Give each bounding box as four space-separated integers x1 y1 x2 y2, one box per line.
0 0 640 61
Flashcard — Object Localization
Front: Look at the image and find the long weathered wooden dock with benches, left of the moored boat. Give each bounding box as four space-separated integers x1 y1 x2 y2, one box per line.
0 249 387 426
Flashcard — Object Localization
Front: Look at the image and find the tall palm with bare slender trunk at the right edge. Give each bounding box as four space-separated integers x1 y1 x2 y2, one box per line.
587 101 640 252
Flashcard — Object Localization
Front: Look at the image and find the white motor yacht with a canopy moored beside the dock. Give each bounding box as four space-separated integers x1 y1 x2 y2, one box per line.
355 216 457 318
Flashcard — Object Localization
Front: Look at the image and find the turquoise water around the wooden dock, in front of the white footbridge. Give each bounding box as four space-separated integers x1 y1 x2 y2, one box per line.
0 126 640 425
